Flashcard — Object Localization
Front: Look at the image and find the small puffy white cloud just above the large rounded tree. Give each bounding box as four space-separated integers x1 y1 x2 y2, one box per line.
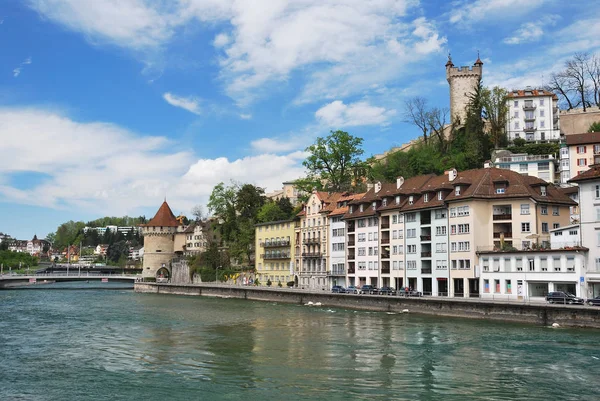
315 100 396 128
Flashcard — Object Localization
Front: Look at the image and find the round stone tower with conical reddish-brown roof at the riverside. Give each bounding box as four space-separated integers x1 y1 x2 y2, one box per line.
141 200 183 277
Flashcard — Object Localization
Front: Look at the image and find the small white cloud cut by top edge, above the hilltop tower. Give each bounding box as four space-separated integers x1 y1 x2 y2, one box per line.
450 0 548 24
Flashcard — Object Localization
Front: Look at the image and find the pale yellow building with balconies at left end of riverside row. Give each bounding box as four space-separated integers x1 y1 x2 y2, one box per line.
254 220 295 286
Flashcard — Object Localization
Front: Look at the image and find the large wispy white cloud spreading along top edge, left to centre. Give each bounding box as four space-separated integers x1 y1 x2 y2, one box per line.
30 0 448 104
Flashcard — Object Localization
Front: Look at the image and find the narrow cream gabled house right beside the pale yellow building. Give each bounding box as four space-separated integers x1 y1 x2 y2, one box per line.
295 191 342 290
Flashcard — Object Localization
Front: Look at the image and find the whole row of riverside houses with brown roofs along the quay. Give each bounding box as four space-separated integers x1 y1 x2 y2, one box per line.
256 163 600 299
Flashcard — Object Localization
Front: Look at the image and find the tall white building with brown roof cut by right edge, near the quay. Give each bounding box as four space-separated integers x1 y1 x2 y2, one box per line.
570 164 600 298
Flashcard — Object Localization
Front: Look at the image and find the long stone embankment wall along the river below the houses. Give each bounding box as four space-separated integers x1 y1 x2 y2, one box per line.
135 283 600 328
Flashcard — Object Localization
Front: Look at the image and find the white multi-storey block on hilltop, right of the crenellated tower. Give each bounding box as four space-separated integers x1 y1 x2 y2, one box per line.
506 87 560 142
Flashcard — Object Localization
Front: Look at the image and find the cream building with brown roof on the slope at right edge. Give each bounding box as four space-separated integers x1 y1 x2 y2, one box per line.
561 132 600 178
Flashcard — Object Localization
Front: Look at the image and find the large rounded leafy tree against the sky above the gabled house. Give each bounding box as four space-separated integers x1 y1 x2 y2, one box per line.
302 130 368 191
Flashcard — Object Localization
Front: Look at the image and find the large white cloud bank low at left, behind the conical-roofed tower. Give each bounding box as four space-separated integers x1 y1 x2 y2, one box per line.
0 108 304 215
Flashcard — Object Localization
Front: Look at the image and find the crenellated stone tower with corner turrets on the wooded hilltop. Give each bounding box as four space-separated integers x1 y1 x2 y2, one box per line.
446 54 483 124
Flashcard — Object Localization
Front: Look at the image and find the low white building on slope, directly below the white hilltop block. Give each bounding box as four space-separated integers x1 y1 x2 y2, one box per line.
494 153 558 183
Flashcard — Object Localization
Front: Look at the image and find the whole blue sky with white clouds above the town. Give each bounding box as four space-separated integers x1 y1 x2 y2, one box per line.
0 0 600 239
